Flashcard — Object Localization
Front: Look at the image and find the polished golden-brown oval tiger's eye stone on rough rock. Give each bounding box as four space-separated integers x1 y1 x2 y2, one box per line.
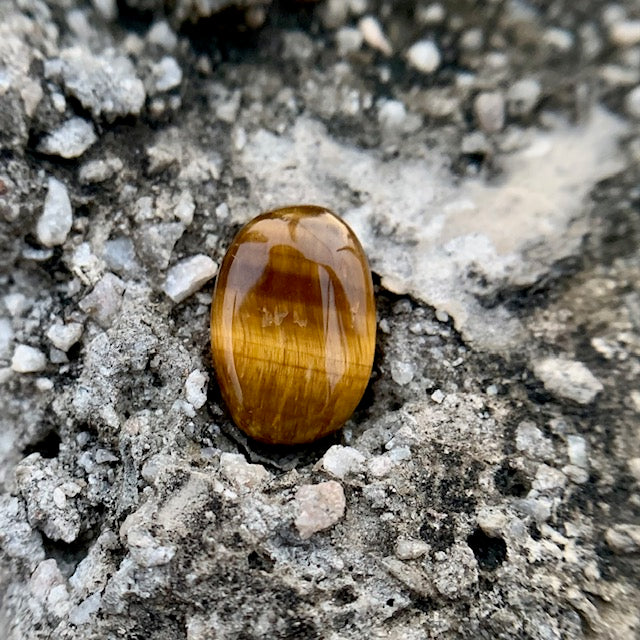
211 206 376 444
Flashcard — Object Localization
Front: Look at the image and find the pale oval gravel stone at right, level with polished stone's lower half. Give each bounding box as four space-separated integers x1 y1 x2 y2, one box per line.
533 358 604 404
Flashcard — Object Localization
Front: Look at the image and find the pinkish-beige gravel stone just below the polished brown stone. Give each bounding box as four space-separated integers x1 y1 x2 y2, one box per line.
295 480 347 540
